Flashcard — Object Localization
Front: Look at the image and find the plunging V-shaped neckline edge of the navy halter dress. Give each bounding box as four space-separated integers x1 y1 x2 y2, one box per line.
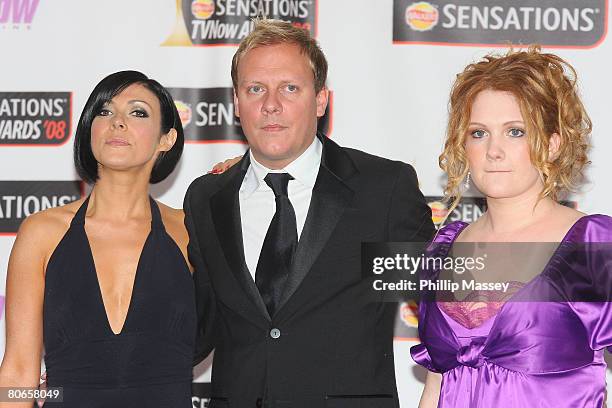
75 196 162 337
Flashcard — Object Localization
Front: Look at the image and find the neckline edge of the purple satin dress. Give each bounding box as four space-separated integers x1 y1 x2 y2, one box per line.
433 214 590 334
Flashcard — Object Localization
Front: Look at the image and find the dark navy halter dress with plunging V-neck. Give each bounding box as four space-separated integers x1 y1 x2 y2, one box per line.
43 198 196 408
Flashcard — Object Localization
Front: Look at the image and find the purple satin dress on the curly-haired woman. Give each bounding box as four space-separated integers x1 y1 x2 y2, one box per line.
411 215 612 408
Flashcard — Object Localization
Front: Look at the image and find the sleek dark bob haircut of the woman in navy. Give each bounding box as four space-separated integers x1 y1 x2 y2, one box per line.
74 71 185 184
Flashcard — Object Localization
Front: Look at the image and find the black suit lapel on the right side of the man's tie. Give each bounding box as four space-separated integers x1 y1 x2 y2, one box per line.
279 135 357 312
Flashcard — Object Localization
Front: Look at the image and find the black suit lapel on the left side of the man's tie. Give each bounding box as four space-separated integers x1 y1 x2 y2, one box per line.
210 153 270 320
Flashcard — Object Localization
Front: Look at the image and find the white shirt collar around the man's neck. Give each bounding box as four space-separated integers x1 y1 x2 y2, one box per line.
240 137 323 196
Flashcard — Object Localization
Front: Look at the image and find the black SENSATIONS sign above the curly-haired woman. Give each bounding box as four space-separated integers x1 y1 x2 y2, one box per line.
393 0 608 48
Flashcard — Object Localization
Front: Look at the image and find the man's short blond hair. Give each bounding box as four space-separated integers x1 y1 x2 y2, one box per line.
232 19 327 94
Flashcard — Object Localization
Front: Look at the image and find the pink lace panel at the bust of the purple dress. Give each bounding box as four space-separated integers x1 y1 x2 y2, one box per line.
437 281 525 329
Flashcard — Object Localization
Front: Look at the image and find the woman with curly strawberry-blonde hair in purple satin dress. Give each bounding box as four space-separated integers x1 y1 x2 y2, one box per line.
411 47 612 408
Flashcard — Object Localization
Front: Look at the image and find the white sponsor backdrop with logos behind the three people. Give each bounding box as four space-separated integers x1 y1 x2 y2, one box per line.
0 0 612 407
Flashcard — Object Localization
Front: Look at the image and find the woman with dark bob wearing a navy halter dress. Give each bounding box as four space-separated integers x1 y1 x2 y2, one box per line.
0 71 196 408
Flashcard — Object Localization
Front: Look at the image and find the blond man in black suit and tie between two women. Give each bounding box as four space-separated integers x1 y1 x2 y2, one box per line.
184 20 434 408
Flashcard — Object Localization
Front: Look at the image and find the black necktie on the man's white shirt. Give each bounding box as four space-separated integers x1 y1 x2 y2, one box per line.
255 173 297 317
